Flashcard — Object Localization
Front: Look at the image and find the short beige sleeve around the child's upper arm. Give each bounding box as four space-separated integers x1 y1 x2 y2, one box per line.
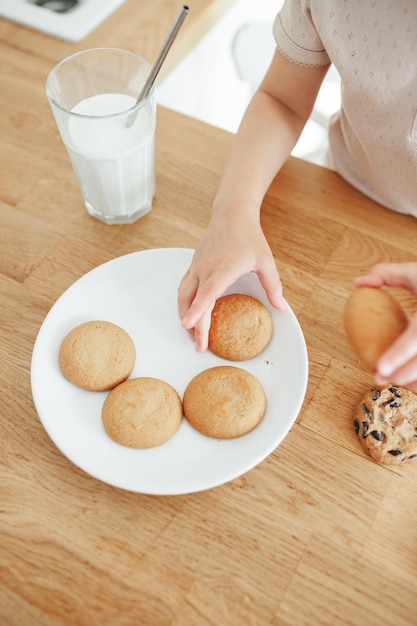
274 0 330 65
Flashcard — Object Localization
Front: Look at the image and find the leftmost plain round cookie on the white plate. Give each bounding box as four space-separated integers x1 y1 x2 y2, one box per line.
59 321 136 391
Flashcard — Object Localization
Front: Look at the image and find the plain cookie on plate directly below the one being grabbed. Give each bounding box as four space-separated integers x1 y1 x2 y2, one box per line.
183 365 266 439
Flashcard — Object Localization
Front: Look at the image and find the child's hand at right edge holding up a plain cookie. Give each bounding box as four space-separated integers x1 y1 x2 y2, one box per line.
354 263 417 390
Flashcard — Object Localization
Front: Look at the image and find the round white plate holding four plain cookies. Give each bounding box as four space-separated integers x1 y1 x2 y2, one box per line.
31 248 308 495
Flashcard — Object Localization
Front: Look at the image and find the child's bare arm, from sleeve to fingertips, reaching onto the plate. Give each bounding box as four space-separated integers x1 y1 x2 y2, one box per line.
178 51 328 351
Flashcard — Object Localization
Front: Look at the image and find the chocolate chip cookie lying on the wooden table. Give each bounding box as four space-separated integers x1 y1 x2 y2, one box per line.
354 385 417 465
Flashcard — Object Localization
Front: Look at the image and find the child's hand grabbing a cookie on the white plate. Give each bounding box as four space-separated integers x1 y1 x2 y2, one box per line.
178 213 285 352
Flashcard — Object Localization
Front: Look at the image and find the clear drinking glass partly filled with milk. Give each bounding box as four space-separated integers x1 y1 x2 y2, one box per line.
46 48 156 224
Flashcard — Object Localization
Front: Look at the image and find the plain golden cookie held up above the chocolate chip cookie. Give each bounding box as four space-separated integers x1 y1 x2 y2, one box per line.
344 287 408 372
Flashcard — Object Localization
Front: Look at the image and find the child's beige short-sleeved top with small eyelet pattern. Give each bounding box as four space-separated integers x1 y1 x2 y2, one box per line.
274 0 417 216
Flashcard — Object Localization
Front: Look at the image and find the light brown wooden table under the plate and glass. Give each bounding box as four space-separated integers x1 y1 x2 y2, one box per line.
0 0 417 626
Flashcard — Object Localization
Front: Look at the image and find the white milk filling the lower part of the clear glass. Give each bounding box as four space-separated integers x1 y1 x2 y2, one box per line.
66 93 155 224
